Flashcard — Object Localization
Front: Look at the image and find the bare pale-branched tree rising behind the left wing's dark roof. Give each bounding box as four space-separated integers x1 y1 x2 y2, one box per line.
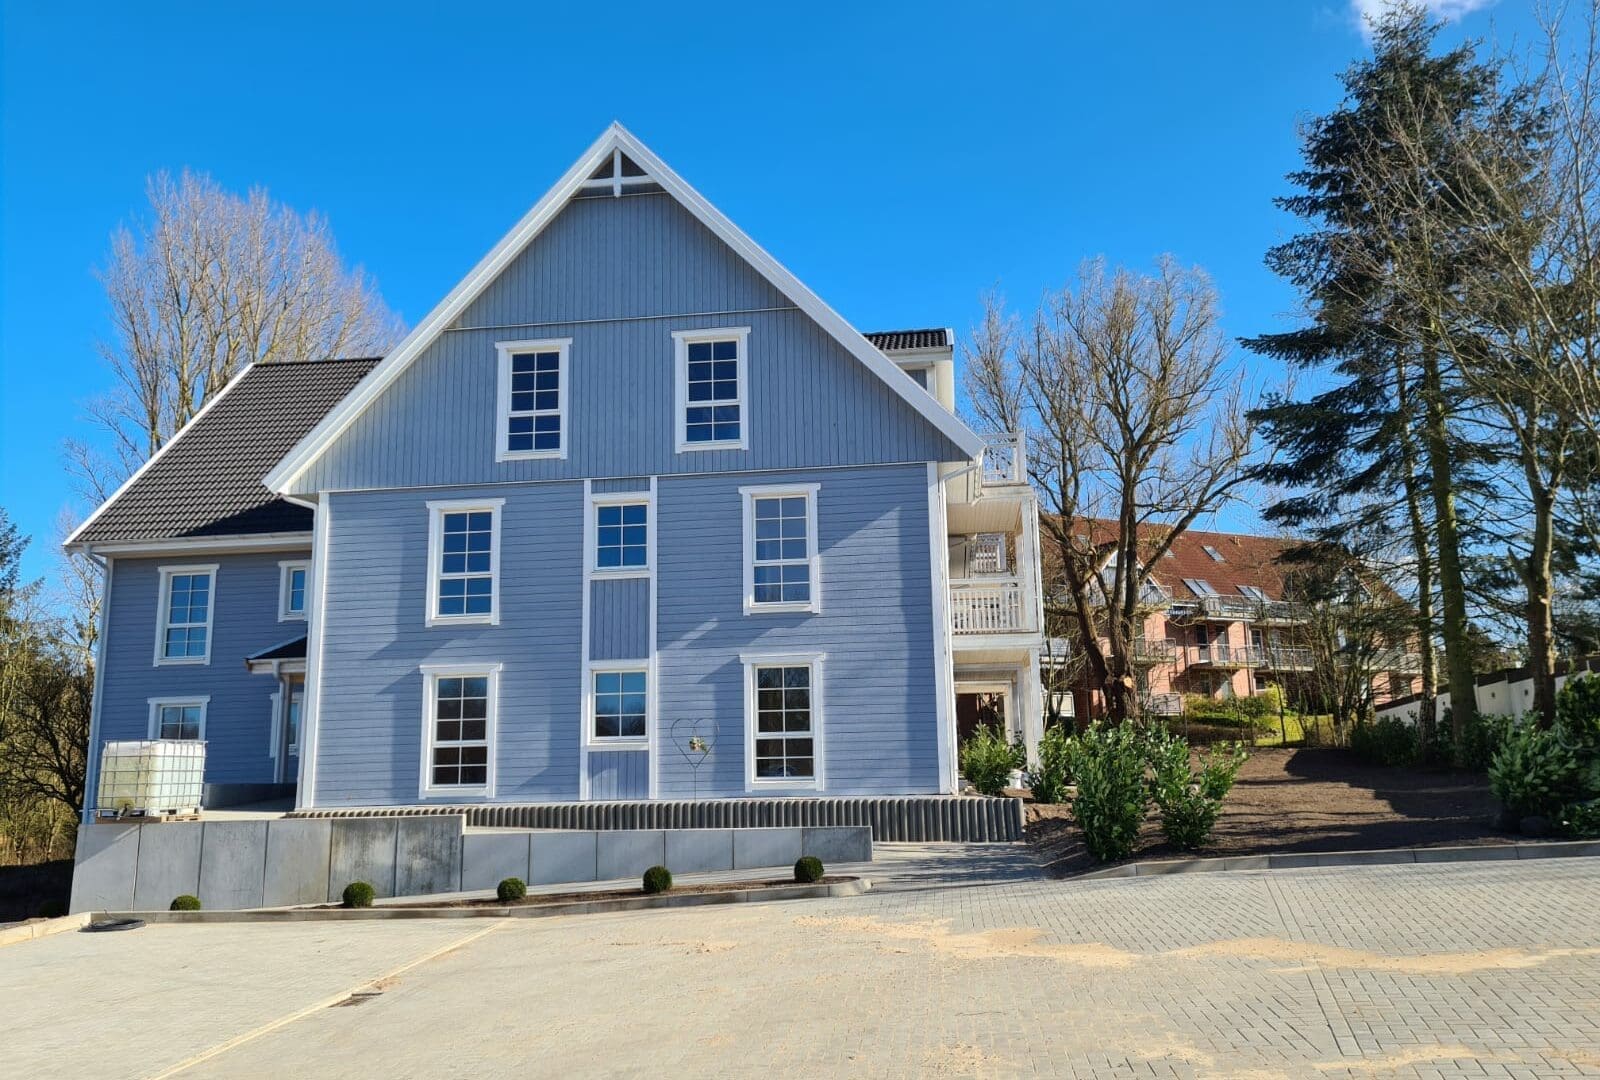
67 171 402 501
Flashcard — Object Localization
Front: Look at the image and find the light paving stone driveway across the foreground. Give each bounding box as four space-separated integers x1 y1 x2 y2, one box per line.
0 859 1600 1078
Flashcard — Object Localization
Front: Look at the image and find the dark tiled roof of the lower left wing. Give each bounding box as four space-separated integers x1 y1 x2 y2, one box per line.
66 358 378 546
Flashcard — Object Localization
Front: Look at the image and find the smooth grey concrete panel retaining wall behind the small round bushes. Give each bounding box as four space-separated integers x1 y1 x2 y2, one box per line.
70 813 872 912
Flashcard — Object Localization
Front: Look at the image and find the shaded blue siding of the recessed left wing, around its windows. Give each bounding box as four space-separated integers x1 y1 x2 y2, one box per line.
91 552 307 798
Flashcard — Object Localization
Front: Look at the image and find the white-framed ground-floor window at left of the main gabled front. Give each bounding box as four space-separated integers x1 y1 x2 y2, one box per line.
421 664 501 795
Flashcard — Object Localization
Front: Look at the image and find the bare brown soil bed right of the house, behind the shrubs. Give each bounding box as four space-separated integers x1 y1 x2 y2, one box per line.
1026 747 1518 877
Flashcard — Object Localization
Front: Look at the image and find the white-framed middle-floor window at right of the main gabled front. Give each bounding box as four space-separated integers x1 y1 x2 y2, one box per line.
739 483 822 614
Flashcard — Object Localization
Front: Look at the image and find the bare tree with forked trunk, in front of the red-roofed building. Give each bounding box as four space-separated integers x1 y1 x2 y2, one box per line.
966 258 1254 720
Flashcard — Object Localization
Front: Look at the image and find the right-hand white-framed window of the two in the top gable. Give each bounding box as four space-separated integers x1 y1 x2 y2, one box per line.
672 326 750 453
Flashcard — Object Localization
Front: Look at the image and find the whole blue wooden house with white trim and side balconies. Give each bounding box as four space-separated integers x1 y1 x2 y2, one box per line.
69 125 1042 808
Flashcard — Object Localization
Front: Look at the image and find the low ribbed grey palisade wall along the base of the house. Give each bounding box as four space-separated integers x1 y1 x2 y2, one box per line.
294 795 1022 843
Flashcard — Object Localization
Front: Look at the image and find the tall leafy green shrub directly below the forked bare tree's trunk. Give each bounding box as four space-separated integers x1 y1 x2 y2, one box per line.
1067 722 1149 862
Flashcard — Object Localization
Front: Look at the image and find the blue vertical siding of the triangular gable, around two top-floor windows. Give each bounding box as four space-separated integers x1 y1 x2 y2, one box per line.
286 195 965 493
